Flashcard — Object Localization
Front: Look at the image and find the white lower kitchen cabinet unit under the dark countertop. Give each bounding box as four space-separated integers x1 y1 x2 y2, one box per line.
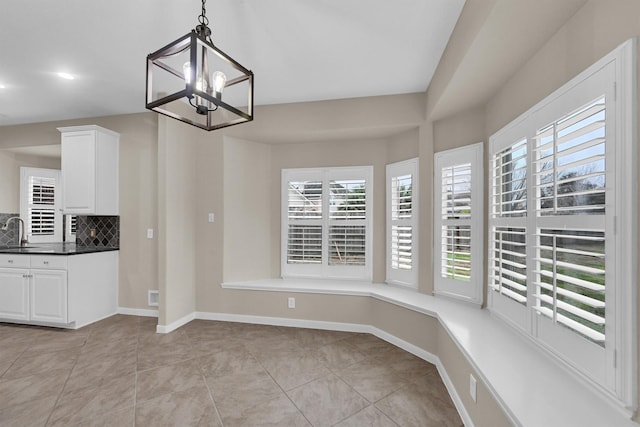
0 251 118 328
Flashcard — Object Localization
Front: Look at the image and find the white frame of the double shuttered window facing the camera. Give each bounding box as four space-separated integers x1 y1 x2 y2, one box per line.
280 166 373 281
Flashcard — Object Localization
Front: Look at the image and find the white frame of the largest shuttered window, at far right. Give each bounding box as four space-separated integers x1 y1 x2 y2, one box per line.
488 39 638 410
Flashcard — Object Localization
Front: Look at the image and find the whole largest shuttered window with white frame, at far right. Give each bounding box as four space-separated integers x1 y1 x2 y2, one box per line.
489 42 637 407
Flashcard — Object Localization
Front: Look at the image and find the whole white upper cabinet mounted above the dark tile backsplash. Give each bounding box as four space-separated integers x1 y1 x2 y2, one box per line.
58 125 120 215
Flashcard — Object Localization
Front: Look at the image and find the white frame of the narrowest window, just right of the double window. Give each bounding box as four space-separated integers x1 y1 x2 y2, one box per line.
386 157 420 289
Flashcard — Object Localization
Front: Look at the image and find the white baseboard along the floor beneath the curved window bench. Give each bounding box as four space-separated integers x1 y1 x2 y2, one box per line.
190 311 474 427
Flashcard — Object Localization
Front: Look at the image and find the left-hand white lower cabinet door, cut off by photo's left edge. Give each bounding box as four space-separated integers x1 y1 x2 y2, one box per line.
0 268 29 320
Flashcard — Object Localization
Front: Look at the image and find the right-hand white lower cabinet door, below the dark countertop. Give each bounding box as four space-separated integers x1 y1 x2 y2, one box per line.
31 270 67 324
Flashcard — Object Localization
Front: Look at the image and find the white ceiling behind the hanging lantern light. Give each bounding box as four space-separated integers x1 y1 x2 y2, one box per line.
0 0 464 126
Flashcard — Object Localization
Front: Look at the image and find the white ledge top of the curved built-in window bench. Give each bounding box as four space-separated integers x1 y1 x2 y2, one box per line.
222 279 638 427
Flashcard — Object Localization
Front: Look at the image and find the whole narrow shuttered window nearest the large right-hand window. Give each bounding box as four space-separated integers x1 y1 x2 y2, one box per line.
434 143 484 304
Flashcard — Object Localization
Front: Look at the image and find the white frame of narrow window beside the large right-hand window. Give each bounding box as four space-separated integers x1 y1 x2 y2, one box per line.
433 142 484 305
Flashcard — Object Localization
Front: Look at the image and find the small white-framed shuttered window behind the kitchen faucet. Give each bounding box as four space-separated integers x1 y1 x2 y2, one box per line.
20 167 62 243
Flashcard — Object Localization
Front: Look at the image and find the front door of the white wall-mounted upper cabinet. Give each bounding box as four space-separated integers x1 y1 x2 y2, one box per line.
62 131 96 215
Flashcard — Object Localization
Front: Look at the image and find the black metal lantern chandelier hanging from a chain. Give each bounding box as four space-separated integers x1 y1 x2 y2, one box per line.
146 0 253 130
